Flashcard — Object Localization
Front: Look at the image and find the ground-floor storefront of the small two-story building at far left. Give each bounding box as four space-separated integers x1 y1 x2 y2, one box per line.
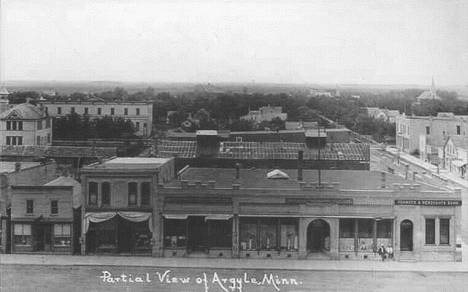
12 220 73 254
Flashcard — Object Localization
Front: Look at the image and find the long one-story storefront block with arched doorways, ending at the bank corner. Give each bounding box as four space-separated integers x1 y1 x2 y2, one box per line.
158 167 461 261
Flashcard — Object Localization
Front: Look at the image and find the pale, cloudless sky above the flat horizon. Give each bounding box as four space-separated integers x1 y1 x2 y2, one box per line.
0 0 468 85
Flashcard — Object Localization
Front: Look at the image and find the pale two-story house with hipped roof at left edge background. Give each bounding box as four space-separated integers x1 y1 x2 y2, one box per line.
0 103 52 146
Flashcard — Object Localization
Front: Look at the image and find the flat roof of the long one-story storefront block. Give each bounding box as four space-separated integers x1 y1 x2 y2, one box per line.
165 168 446 191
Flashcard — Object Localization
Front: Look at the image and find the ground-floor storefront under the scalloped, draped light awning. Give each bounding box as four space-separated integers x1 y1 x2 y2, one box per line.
83 212 153 255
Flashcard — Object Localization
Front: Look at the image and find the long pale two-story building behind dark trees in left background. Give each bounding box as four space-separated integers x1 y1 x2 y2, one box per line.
39 97 153 136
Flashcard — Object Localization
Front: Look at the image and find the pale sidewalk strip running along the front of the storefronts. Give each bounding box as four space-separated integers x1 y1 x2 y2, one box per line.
0 254 468 273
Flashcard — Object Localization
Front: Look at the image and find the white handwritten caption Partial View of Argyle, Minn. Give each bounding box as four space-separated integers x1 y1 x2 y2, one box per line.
99 270 302 292
